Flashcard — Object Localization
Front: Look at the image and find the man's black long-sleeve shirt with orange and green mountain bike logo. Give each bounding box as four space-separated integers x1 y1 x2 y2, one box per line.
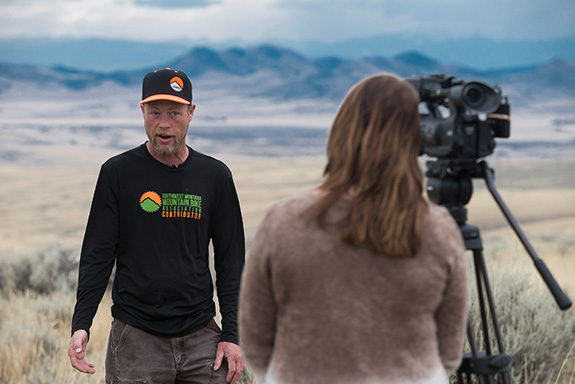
72 144 245 343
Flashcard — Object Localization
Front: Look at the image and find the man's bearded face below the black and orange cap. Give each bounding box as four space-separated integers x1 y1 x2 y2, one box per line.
141 100 196 157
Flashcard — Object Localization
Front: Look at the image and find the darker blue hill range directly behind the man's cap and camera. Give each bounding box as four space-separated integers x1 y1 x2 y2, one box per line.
0 45 575 104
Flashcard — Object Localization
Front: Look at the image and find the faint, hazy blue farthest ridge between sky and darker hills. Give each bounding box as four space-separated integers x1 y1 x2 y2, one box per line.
0 34 575 72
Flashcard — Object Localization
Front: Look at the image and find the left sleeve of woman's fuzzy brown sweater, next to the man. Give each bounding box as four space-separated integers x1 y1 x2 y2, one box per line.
239 208 277 382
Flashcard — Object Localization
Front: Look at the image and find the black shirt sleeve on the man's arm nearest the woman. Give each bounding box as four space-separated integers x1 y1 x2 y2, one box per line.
212 175 245 344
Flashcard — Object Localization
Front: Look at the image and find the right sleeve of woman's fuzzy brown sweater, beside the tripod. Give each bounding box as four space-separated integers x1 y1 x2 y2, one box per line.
435 208 469 374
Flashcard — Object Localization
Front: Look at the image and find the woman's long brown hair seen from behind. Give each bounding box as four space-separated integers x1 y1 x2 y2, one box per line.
311 75 427 257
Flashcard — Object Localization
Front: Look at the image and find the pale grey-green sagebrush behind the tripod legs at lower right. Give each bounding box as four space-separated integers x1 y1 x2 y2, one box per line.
464 250 575 383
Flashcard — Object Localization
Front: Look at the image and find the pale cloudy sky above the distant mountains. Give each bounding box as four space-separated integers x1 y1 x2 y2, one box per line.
0 0 575 43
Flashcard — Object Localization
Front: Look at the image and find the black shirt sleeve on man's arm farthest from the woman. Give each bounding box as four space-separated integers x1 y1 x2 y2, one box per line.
72 166 119 333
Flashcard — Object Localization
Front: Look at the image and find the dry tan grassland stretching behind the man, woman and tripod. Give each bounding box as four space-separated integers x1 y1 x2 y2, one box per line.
0 149 575 384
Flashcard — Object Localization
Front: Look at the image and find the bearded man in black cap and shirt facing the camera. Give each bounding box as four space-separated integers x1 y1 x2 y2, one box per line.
68 68 245 384
